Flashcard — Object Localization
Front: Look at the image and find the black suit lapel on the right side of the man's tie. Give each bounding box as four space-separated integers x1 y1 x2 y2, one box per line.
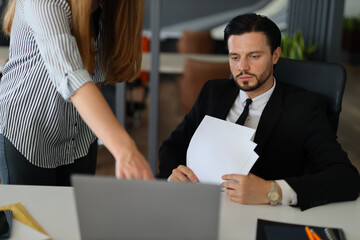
254 82 284 156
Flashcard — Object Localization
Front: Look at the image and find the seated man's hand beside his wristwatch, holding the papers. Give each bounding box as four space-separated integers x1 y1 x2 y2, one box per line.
221 173 282 204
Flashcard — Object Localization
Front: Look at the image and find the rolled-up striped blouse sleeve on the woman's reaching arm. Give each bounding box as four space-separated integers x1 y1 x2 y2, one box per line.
24 0 92 100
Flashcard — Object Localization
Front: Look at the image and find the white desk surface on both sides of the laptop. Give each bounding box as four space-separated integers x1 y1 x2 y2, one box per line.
0 185 360 240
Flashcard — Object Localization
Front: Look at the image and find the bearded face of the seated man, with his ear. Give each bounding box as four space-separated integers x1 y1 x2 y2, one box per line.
228 32 280 97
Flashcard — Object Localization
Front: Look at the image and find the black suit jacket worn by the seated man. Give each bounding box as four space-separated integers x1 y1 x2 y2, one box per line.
158 79 360 210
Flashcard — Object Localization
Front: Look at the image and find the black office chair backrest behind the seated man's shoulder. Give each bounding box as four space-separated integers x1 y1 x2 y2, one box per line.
274 58 346 134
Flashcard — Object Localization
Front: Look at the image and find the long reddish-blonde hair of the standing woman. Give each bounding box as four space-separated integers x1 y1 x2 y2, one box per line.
3 0 144 83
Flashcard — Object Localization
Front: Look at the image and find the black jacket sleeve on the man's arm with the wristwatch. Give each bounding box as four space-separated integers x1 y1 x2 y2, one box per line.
285 94 360 210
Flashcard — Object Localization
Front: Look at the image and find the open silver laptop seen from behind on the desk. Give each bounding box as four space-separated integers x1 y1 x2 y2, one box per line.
72 175 220 240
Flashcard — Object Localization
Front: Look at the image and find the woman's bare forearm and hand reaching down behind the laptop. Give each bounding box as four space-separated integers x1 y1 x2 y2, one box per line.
70 82 154 179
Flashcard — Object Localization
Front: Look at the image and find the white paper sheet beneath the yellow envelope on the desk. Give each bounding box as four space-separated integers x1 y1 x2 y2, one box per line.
9 219 50 240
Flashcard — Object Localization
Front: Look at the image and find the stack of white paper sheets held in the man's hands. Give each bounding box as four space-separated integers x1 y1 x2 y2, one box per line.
186 116 258 185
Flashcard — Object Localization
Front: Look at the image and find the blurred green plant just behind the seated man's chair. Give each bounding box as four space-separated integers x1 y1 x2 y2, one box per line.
280 30 319 60
